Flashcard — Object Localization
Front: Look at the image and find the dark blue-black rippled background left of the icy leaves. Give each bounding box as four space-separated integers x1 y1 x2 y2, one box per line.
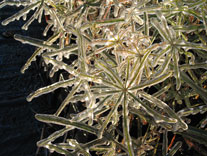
0 7 47 156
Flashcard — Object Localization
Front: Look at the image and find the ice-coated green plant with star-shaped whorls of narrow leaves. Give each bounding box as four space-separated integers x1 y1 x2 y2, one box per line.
0 0 207 156
